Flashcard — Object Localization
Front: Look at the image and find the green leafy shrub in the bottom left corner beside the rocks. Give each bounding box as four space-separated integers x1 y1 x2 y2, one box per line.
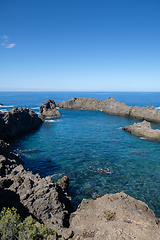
0 208 56 240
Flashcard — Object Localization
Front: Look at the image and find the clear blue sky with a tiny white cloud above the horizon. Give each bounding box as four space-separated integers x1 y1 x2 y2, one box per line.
0 0 160 91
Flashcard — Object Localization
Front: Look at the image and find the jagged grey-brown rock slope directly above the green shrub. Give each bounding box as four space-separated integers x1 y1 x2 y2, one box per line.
0 141 73 236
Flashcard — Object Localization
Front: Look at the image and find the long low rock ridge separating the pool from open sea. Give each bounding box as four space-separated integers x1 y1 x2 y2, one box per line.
56 97 160 123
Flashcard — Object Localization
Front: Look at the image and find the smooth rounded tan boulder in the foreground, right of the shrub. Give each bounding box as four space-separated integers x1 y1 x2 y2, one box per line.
70 192 160 240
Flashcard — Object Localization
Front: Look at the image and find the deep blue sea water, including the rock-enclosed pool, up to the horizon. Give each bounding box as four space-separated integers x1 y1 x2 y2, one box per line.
0 92 160 217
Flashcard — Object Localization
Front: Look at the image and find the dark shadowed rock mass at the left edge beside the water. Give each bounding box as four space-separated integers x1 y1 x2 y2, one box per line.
0 107 43 139
